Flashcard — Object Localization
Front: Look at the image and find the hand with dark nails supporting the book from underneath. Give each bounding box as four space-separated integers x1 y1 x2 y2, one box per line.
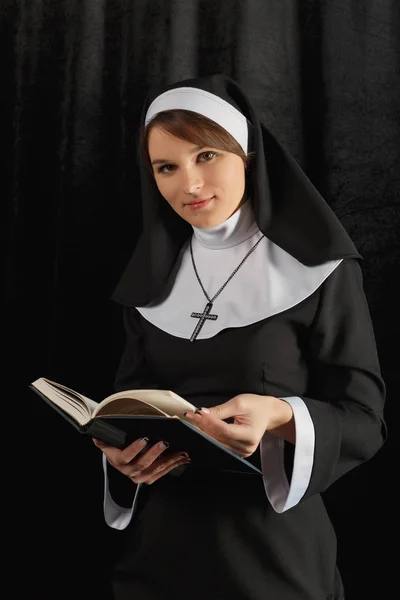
92 438 190 485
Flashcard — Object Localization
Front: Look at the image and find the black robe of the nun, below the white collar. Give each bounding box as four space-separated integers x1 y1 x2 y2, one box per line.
106 259 385 600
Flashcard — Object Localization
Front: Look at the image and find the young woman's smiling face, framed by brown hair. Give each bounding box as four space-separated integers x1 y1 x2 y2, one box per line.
148 126 245 229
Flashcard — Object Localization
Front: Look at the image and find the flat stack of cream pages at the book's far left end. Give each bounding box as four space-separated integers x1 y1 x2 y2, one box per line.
32 377 94 425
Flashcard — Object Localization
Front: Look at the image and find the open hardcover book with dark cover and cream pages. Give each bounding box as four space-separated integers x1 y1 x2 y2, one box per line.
29 377 261 474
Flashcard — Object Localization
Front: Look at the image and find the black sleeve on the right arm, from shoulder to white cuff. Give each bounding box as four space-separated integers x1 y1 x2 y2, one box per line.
302 259 386 498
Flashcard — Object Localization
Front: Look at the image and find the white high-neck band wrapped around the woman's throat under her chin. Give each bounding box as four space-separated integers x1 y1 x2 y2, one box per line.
193 200 259 250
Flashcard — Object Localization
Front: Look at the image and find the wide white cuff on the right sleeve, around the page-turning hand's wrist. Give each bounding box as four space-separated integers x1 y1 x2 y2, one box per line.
260 396 315 513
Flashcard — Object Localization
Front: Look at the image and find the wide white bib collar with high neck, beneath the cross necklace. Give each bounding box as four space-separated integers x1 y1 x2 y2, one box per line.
137 202 341 340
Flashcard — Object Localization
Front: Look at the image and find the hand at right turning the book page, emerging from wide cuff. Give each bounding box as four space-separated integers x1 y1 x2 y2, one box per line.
185 394 295 458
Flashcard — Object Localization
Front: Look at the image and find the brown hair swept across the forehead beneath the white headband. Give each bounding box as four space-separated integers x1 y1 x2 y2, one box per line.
139 109 254 173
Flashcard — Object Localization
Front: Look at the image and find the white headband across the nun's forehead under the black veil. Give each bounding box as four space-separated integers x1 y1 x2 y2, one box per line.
145 87 248 155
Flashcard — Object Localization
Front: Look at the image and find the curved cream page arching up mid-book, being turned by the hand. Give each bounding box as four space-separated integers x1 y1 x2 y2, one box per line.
93 390 196 418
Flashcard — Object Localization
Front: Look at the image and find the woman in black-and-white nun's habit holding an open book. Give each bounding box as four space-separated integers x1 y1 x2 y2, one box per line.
95 75 385 600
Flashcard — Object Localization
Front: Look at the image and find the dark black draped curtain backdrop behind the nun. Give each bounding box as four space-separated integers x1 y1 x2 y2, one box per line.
0 0 400 600
